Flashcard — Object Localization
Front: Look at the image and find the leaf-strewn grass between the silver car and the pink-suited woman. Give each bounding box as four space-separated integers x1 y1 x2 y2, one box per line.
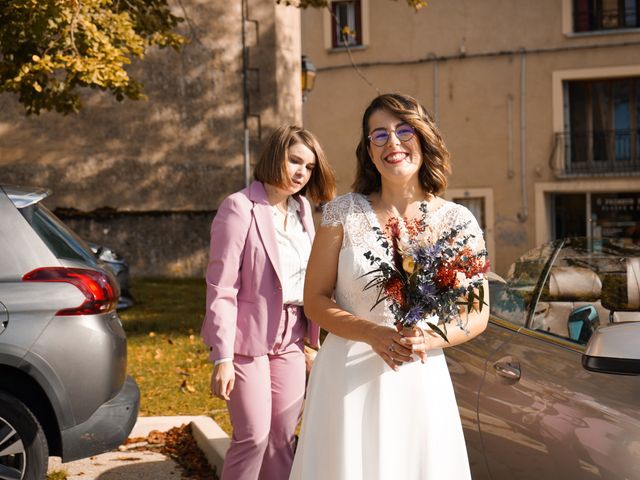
120 278 231 435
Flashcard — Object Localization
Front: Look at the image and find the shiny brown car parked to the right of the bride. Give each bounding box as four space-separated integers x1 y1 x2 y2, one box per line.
447 238 640 480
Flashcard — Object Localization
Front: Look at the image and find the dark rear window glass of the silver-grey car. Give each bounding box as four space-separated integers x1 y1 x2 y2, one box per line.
20 203 96 266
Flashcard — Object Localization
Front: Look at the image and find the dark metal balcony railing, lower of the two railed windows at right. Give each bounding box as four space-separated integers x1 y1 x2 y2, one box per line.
549 130 640 177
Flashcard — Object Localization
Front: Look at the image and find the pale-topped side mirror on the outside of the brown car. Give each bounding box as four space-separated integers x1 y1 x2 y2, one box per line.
582 322 640 375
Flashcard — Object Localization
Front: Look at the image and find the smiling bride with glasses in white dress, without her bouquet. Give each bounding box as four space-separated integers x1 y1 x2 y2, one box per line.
290 94 489 480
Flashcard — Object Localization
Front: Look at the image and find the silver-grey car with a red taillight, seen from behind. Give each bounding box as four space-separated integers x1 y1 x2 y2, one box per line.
0 186 140 479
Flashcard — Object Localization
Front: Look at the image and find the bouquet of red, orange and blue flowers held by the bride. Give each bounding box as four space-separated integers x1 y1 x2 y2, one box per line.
364 204 489 342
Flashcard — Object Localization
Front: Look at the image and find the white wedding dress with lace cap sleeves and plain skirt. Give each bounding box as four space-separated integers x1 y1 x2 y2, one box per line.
289 193 484 480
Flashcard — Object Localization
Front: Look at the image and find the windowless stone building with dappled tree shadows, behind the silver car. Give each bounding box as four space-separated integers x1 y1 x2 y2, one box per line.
0 0 302 276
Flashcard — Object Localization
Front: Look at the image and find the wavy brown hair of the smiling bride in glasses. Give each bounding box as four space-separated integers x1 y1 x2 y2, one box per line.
352 93 451 195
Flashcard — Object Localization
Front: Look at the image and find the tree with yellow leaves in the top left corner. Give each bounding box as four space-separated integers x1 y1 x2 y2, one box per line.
0 0 185 114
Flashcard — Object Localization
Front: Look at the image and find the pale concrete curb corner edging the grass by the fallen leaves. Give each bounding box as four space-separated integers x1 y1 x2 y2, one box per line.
129 415 231 475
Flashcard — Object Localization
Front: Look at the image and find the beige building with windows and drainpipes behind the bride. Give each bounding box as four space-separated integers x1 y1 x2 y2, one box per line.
302 0 640 273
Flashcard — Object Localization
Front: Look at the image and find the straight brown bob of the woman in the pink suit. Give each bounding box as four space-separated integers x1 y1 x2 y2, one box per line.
253 125 336 203
